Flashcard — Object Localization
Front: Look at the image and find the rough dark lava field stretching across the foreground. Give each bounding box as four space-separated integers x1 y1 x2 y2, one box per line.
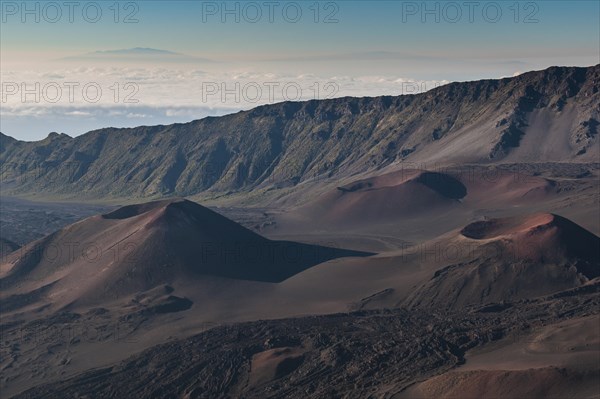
16 284 600 398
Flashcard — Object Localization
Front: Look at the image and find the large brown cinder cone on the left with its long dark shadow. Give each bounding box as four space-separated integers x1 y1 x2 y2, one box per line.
0 200 368 310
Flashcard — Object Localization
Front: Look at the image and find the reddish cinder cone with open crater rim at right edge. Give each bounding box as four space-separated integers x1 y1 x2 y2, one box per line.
406 214 600 308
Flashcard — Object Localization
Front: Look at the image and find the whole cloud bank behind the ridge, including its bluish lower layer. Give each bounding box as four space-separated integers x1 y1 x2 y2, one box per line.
0 65 447 138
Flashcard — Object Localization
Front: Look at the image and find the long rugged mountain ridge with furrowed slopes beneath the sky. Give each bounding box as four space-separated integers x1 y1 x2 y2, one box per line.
0 65 600 202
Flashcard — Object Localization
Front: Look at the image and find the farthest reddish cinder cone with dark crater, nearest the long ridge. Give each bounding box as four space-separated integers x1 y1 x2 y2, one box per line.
290 168 558 229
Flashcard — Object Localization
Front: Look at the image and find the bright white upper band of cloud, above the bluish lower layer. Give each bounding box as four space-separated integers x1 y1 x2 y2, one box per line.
0 67 447 110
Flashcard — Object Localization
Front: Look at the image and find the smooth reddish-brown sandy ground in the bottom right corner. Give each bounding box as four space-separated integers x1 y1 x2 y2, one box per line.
395 315 600 399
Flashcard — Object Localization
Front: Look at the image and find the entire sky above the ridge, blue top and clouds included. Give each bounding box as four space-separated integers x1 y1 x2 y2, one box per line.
0 0 600 140
